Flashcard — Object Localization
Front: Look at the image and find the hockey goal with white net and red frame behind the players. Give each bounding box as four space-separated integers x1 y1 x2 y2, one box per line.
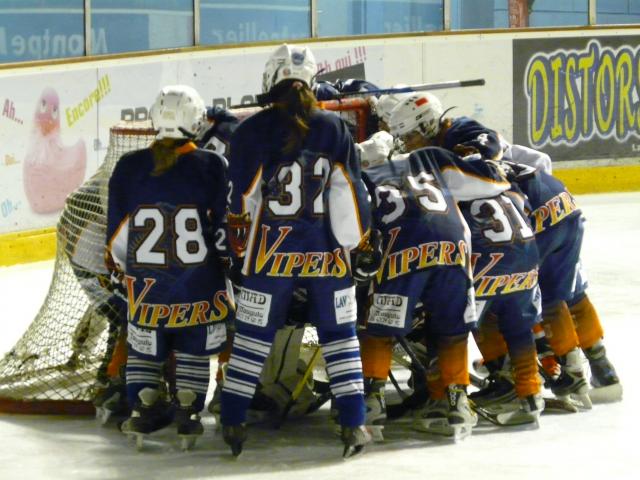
0 98 370 415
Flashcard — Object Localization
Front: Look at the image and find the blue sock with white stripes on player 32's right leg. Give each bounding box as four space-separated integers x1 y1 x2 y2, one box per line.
318 326 362 427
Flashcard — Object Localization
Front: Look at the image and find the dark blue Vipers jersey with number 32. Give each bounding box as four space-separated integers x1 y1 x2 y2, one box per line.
229 108 370 278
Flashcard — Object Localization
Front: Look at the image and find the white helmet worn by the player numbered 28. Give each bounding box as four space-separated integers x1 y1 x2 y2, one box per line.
149 85 206 140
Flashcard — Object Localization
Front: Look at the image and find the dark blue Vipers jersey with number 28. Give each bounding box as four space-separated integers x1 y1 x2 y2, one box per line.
107 143 229 328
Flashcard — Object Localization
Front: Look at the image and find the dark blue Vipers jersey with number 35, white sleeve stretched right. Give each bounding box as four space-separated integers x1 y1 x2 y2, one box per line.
364 147 509 282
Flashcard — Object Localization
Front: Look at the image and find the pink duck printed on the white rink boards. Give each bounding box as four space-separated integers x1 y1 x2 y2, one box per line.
23 88 87 213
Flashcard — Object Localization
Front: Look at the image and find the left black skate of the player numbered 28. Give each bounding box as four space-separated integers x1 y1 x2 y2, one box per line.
120 388 174 450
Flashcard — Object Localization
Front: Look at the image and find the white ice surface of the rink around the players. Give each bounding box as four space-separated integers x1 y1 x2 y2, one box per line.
0 193 640 480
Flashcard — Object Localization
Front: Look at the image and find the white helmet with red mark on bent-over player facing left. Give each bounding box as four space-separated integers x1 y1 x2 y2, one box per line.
389 93 444 138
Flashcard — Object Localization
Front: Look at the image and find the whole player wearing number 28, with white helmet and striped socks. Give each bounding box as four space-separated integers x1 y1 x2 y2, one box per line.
107 85 232 448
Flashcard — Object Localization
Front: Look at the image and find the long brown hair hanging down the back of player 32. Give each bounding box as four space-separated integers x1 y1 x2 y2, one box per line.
270 80 318 154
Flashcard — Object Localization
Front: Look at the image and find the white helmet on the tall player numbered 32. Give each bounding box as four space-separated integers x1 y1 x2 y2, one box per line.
262 43 318 93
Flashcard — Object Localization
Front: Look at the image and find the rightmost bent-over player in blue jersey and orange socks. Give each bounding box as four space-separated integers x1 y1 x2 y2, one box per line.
490 162 622 408
